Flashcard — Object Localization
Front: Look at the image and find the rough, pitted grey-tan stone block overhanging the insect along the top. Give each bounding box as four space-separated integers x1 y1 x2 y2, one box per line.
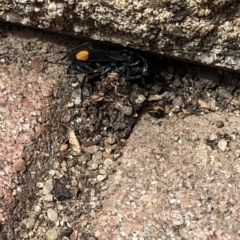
0 0 240 70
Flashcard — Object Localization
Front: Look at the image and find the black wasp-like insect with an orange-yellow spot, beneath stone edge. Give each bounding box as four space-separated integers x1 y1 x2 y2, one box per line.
62 43 149 80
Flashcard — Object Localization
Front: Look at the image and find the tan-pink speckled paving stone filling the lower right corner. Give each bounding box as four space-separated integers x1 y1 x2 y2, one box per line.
95 113 240 240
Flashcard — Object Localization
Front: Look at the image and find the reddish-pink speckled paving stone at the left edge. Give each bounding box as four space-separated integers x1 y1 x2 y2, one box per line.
0 64 53 221
